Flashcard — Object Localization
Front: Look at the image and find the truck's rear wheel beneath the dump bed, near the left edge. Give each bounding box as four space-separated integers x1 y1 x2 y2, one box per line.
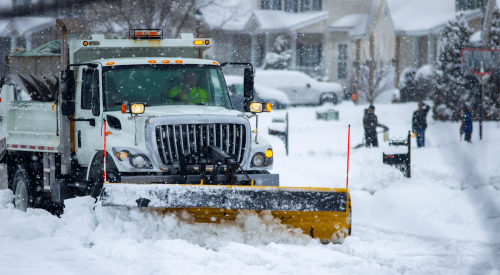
12 167 34 212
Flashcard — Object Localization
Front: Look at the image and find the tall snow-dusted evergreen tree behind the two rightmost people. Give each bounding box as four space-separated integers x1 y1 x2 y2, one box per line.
433 14 473 121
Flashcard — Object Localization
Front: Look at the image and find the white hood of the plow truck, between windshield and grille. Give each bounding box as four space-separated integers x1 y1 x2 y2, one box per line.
105 105 241 134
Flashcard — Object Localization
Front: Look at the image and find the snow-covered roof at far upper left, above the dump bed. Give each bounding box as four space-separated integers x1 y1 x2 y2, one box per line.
0 17 56 37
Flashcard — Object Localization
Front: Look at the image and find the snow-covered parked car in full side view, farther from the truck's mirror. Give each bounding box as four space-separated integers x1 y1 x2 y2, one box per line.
255 70 343 105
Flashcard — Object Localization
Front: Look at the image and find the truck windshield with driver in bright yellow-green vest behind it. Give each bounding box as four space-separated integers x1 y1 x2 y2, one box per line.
103 64 231 111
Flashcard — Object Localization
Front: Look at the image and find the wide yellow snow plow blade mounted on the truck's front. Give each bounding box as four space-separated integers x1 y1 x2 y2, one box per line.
101 183 351 242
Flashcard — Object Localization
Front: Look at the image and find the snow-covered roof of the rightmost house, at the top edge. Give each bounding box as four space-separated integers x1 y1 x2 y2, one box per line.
385 0 482 34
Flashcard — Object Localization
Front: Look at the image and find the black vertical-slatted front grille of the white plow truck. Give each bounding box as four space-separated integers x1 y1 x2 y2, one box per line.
156 123 246 165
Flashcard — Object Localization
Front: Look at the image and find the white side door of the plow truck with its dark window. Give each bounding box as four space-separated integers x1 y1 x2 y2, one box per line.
74 67 103 166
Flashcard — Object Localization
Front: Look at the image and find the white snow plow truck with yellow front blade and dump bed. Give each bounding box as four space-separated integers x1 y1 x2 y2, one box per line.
0 20 351 242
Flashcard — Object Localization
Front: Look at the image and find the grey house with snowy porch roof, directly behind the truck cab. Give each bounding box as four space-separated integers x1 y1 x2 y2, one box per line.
209 0 331 75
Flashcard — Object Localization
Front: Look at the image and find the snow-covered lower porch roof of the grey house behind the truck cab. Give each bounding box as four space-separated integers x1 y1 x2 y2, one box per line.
246 10 328 30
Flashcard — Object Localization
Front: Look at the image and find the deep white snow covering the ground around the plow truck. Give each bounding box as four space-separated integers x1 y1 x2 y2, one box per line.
0 102 500 275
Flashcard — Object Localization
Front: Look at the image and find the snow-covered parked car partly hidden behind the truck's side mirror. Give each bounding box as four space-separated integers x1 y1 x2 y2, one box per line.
225 75 290 111
